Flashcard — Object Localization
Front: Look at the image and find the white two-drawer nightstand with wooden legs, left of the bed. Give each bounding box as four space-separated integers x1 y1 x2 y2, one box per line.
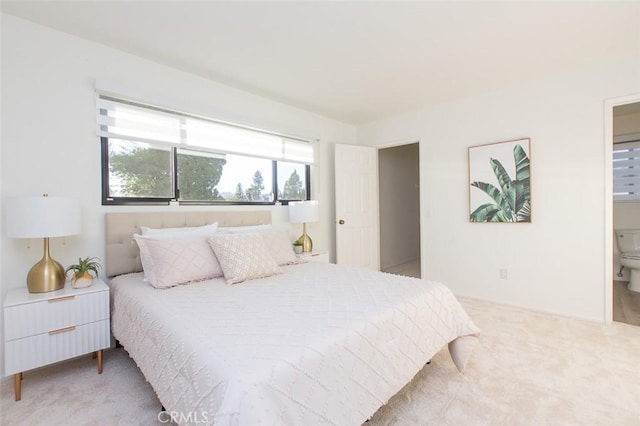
4 280 111 401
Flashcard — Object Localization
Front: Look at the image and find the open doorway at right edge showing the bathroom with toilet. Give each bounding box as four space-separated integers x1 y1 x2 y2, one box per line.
612 102 640 326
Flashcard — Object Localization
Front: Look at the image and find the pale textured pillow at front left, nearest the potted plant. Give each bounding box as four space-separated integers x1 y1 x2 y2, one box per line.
134 235 223 288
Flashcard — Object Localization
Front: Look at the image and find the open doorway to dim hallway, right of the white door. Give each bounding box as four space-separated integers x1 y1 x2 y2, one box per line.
378 142 422 278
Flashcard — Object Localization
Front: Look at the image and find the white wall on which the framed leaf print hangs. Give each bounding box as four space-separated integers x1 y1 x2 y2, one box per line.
358 56 640 321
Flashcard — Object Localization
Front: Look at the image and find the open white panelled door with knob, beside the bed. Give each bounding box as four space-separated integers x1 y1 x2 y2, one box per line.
335 144 380 270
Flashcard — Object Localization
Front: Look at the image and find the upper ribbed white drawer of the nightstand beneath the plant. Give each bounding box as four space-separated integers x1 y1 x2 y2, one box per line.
4 291 109 341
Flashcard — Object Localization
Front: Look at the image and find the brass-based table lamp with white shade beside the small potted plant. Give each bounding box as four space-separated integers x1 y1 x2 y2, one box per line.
5 194 82 293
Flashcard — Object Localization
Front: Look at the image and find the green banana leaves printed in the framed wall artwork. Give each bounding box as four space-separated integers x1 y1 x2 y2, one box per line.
469 140 531 222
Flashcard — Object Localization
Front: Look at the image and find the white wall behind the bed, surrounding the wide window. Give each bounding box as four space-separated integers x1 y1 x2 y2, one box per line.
0 14 355 378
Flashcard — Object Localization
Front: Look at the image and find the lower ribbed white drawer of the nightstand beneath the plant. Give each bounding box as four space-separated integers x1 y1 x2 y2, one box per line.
4 318 111 374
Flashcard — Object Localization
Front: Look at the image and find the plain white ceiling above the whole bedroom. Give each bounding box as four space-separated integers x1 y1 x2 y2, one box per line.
0 0 640 125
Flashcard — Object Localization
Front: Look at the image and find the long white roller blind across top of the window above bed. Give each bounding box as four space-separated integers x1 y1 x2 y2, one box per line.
97 94 315 164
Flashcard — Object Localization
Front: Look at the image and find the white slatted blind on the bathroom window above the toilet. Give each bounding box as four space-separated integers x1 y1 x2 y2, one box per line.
613 140 640 201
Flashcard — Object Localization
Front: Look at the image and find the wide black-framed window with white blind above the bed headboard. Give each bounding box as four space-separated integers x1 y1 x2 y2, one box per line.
98 95 315 204
